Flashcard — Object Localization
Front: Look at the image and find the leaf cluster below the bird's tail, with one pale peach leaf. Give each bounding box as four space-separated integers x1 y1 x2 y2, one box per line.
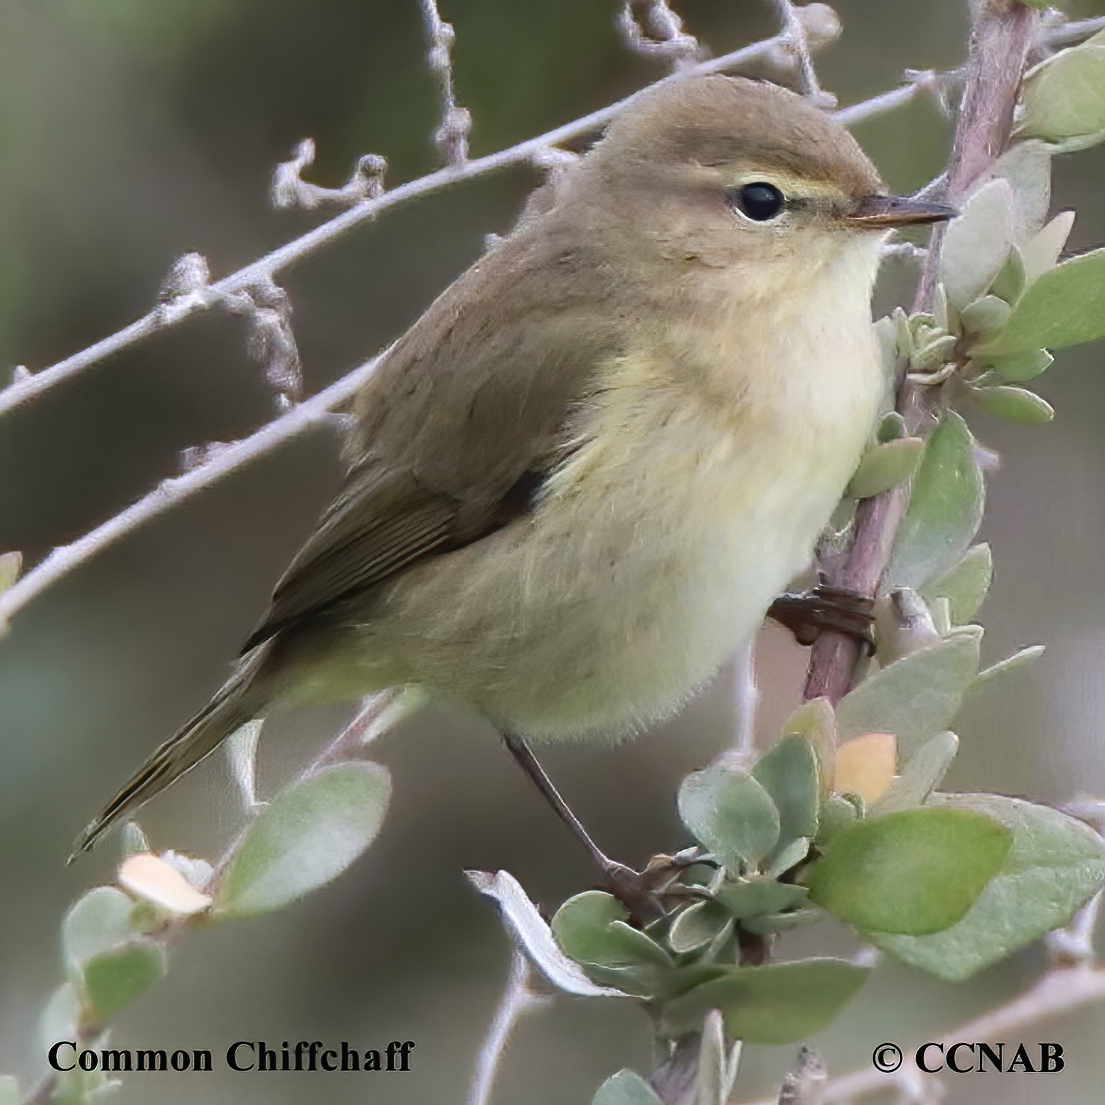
19 761 390 1105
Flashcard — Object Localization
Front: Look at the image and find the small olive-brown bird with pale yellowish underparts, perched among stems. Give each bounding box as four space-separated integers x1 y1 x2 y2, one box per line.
77 76 954 849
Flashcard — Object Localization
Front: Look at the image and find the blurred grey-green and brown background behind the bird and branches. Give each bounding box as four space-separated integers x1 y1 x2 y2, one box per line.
0 0 1105 1105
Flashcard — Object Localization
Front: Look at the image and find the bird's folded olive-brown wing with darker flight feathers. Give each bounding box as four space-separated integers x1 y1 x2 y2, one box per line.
243 227 622 651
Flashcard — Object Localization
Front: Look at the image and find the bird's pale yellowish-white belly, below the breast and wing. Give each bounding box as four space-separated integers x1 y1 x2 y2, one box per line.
369 388 867 738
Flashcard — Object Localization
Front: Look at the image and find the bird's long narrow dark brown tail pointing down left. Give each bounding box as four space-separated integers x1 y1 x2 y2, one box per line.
70 645 270 863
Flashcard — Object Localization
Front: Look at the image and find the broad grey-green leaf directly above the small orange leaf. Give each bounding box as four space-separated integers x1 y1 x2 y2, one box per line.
836 629 979 760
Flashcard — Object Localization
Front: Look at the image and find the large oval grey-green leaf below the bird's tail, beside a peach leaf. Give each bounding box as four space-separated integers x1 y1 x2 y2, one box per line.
214 761 391 917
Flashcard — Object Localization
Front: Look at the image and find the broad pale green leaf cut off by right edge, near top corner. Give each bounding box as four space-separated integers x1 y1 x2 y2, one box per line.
1017 42 1105 149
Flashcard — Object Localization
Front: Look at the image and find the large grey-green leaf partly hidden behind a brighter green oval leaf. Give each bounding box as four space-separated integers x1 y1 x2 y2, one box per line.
869 794 1105 982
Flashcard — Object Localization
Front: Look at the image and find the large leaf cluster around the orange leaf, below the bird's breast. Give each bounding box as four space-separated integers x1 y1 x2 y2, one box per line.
553 411 1105 1065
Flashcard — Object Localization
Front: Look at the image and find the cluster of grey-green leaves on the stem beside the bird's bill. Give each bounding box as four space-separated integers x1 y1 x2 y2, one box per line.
850 32 1105 437
